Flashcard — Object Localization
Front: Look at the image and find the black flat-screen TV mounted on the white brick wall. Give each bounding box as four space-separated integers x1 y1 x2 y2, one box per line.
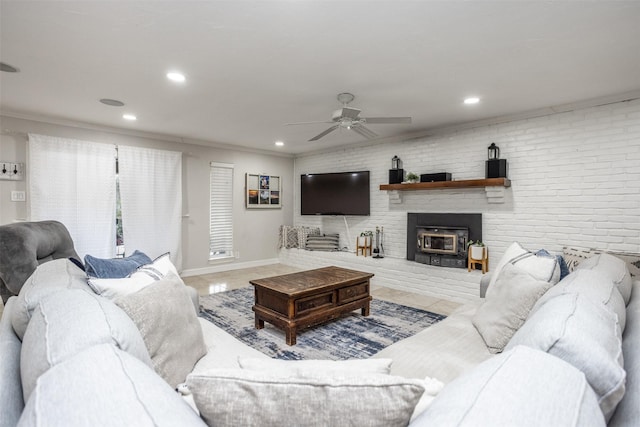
300 171 369 215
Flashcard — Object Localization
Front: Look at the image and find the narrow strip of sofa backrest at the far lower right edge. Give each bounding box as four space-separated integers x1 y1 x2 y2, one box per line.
609 280 640 427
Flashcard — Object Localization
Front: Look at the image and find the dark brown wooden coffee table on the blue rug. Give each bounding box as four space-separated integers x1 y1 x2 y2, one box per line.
249 267 373 345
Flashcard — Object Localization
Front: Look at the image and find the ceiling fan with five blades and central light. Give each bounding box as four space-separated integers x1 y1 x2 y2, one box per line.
286 92 411 141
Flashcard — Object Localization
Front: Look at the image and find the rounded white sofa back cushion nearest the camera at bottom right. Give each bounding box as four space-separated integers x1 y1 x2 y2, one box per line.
411 346 605 427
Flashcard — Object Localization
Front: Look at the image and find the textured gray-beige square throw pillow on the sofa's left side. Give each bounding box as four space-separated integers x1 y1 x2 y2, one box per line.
115 273 207 387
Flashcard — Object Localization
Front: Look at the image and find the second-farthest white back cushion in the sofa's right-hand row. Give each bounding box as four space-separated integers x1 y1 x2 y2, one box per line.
532 269 627 332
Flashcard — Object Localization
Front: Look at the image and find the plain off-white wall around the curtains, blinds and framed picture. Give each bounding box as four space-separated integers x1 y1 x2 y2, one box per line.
0 116 293 274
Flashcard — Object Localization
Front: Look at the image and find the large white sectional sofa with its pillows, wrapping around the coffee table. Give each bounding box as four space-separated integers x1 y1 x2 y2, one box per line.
0 231 640 426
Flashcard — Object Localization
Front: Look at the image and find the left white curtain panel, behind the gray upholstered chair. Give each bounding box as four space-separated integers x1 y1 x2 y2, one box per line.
28 134 116 258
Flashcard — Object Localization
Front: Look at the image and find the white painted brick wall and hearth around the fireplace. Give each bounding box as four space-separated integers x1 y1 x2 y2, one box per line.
280 100 640 300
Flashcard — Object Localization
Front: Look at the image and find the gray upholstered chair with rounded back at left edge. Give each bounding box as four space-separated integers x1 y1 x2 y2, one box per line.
0 221 80 302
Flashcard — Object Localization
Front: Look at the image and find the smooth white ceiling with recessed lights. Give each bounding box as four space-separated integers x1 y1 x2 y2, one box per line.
0 0 640 154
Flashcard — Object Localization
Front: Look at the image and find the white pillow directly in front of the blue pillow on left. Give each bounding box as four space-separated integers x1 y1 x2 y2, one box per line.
88 253 178 300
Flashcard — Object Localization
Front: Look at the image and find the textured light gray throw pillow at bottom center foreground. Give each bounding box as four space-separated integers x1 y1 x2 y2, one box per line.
187 369 424 427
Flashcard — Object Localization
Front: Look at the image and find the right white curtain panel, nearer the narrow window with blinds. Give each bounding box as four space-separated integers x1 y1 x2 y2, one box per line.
118 146 182 271
